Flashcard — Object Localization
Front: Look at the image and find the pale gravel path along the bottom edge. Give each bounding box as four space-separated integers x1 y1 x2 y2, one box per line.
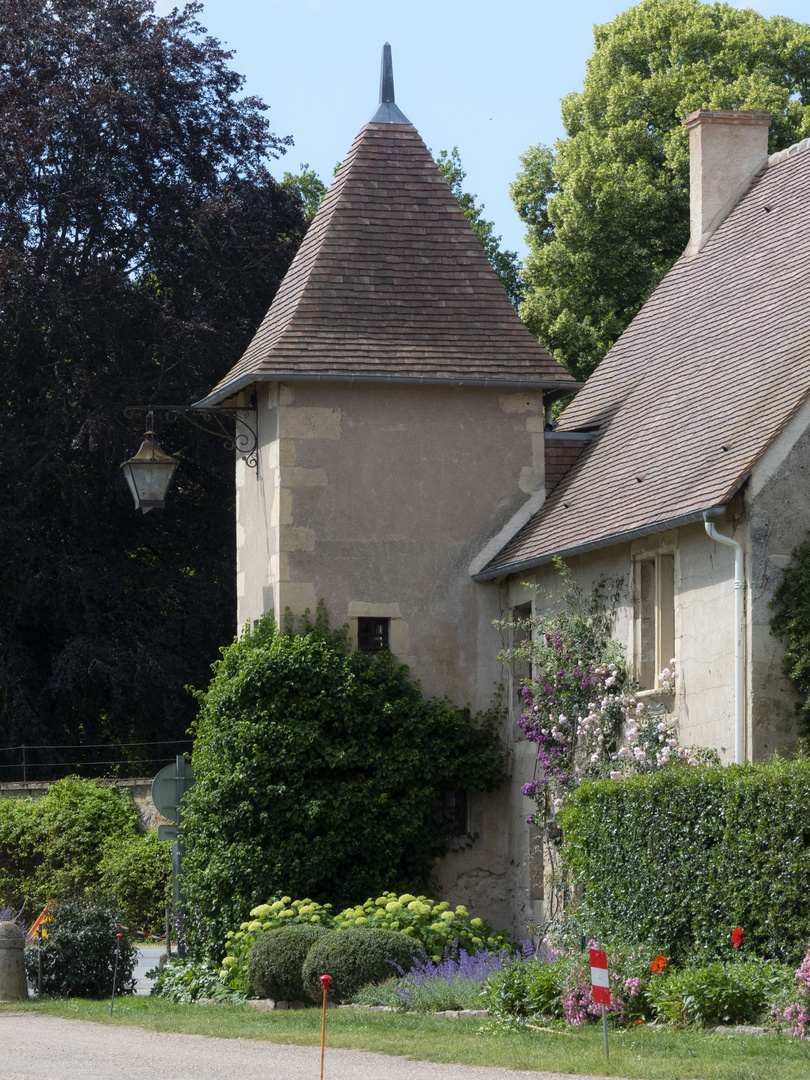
0 1013 616 1080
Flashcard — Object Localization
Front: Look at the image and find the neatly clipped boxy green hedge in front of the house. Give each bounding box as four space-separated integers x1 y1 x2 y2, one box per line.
561 758 810 962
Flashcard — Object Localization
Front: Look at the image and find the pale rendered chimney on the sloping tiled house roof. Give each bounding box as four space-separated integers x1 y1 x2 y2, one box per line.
684 109 771 255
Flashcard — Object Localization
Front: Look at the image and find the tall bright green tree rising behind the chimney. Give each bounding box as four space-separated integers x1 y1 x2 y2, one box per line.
512 0 810 378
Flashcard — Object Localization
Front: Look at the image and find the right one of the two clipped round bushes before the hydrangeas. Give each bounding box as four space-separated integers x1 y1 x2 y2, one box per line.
302 930 419 1001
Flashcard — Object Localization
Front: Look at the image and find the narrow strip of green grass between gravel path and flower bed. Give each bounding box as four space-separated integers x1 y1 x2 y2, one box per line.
0 998 810 1080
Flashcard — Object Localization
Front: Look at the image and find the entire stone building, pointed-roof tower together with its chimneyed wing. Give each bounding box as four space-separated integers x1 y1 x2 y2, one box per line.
199 46 810 932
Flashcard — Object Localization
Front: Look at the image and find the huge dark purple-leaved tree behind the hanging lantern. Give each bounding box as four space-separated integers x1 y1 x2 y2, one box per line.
0 0 305 779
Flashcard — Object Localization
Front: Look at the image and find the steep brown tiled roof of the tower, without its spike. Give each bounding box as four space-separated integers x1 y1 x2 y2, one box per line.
199 53 578 405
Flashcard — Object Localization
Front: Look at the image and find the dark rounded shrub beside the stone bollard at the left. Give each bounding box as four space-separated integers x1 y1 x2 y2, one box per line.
26 897 137 998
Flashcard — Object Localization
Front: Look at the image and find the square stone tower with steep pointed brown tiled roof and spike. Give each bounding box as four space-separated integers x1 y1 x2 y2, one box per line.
199 50 579 929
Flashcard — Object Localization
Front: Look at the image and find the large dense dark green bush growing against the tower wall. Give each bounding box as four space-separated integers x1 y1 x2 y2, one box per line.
184 613 503 958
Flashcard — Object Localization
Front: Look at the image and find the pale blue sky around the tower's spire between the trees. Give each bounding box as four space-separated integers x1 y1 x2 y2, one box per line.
156 0 810 255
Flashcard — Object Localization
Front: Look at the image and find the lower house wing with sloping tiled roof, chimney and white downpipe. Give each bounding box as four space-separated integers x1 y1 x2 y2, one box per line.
472 109 810 777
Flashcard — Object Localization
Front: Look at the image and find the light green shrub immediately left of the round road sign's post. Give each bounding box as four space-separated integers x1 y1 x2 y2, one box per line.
93 833 172 934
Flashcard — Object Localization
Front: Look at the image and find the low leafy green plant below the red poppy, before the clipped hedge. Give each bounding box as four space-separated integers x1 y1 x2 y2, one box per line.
648 960 793 1026
